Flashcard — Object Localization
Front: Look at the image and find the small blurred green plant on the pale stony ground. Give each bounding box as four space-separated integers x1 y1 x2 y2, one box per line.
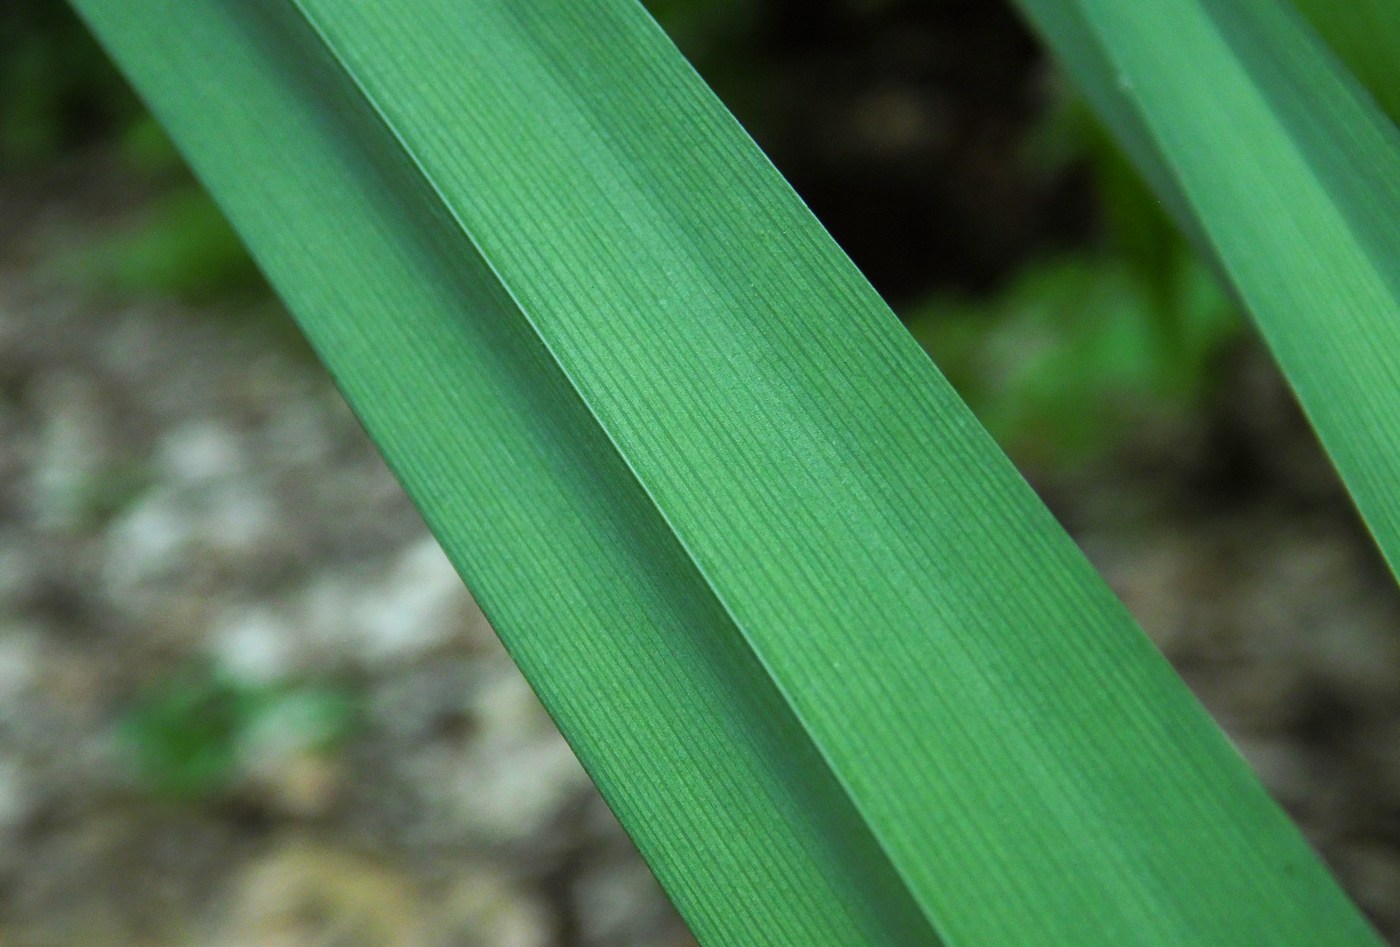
116 667 360 800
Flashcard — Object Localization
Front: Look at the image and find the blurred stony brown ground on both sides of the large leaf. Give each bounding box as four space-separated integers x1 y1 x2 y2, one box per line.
0 201 1400 947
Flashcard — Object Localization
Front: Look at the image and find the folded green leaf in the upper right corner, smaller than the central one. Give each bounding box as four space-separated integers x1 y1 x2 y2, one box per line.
1019 0 1400 572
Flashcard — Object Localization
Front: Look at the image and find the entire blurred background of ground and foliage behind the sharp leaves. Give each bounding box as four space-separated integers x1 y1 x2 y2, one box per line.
0 0 1400 947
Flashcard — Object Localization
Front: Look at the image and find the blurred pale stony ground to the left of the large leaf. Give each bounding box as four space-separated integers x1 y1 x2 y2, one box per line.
0 259 690 947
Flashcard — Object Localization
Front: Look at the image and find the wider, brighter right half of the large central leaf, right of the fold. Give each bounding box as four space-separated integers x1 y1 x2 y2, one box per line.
278 0 1372 941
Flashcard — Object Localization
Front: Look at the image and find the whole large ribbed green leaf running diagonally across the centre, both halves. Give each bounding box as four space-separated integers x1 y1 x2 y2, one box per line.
77 0 1375 947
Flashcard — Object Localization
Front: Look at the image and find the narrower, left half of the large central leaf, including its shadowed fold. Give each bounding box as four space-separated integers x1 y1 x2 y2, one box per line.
63 0 934 944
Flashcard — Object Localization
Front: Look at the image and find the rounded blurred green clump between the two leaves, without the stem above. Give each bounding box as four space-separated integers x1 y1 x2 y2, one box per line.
910 251 1243 469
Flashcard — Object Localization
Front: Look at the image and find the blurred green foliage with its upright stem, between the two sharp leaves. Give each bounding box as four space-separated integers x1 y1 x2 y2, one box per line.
904 91 1245 469
